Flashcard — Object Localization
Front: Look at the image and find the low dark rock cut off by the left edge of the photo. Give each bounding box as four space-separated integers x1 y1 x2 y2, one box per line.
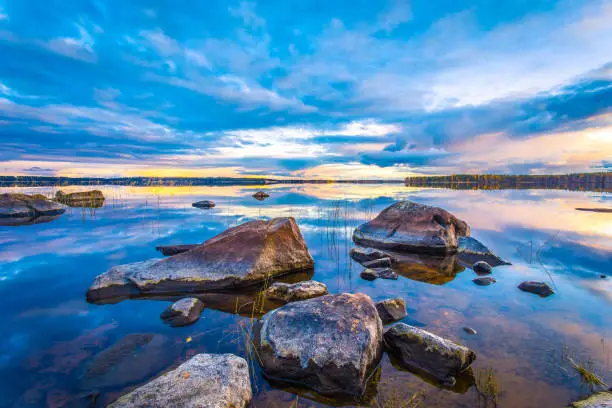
0 193 66 224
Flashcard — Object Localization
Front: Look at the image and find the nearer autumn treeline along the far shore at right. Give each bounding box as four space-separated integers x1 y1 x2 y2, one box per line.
405 172 612 192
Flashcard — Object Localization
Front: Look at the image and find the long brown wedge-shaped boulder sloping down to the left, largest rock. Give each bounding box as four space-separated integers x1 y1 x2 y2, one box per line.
87 218 314 302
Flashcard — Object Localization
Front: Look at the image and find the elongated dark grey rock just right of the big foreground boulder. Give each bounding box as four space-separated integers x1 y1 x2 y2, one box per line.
384 323 476 385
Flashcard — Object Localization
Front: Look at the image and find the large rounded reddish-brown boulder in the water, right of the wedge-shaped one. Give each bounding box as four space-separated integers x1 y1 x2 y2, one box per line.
353 201 470 253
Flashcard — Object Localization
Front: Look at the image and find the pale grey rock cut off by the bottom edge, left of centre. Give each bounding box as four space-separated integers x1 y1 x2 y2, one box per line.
108 354 253 408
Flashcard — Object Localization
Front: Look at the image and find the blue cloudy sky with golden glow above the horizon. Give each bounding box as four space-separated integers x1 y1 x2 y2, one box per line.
0 0 612 179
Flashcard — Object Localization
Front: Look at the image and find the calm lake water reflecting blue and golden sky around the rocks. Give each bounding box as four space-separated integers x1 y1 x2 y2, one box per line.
0 185 612 407
